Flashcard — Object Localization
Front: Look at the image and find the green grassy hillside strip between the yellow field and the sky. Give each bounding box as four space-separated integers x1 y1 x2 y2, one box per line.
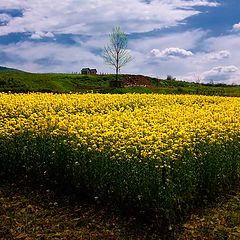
0 71 240 96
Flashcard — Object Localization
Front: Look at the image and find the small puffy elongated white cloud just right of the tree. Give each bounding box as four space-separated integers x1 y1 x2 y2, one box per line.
151 48 193 59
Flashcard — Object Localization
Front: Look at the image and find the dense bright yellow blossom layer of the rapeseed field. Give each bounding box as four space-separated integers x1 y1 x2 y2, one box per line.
0 93 240 165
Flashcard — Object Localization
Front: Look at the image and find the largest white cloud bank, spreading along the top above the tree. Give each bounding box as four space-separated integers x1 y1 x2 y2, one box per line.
0 0 218 35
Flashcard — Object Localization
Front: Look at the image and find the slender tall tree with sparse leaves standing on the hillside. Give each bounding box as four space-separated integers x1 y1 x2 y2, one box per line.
103 27 133 81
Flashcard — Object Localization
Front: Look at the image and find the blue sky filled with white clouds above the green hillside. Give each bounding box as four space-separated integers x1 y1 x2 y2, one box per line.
0 0 240 84
